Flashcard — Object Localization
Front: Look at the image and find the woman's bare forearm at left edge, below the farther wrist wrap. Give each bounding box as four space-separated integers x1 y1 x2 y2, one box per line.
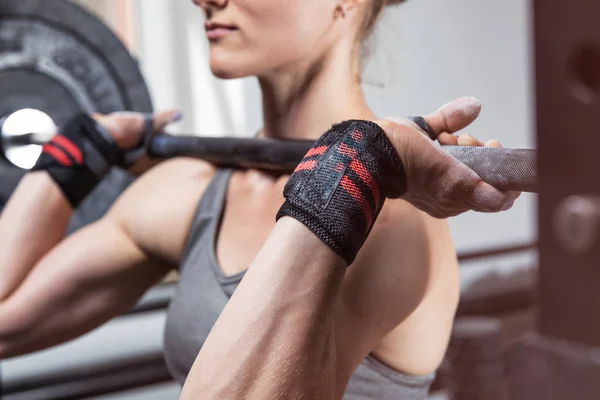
0 172 72 303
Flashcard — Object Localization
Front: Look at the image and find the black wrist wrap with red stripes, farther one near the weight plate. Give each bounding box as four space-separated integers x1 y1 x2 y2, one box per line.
32 114 124 207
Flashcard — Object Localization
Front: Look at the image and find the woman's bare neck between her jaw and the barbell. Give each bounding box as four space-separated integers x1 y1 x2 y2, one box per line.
259 49 374 139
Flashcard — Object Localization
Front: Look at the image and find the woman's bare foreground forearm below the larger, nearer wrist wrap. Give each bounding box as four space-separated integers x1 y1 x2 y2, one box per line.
182 218 346 399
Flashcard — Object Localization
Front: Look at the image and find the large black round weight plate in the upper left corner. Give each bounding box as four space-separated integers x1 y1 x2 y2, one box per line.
0 0 152 230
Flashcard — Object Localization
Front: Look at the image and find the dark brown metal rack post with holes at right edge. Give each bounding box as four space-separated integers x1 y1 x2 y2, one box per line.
509 0 600 400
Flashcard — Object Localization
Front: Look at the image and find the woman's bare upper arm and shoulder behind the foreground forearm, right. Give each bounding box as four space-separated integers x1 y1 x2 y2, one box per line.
336 212 460 382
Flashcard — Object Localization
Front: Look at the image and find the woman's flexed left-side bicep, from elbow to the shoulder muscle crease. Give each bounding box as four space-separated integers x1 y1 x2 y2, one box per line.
0 220 168 358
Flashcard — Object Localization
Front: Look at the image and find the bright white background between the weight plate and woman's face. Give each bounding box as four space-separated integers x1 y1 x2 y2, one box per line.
134 0 251 136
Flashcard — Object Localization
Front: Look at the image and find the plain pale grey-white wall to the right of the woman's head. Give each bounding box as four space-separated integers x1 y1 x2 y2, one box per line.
366 0 536 250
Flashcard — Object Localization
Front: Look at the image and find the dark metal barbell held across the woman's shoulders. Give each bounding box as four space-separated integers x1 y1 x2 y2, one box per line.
0 109 536 192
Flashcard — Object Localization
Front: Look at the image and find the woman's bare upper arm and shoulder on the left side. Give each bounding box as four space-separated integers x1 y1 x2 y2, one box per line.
0 161 216 359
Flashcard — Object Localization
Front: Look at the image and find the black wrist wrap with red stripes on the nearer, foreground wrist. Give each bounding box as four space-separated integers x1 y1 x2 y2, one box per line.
277 120 406 265
